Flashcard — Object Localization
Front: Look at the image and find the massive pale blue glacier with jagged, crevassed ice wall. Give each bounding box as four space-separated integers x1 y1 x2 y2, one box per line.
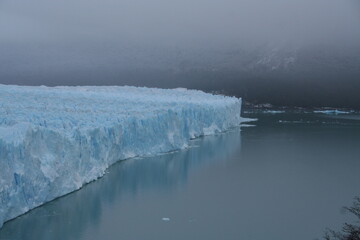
0 85 241 227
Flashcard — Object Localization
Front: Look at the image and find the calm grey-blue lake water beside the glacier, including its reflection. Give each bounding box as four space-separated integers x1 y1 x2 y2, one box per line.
0 112 360 240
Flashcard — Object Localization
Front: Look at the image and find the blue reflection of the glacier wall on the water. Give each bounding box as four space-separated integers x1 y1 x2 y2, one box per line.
0 129 241 240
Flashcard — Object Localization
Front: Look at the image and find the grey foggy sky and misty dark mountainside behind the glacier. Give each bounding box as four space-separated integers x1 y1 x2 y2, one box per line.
0 0 360 108
